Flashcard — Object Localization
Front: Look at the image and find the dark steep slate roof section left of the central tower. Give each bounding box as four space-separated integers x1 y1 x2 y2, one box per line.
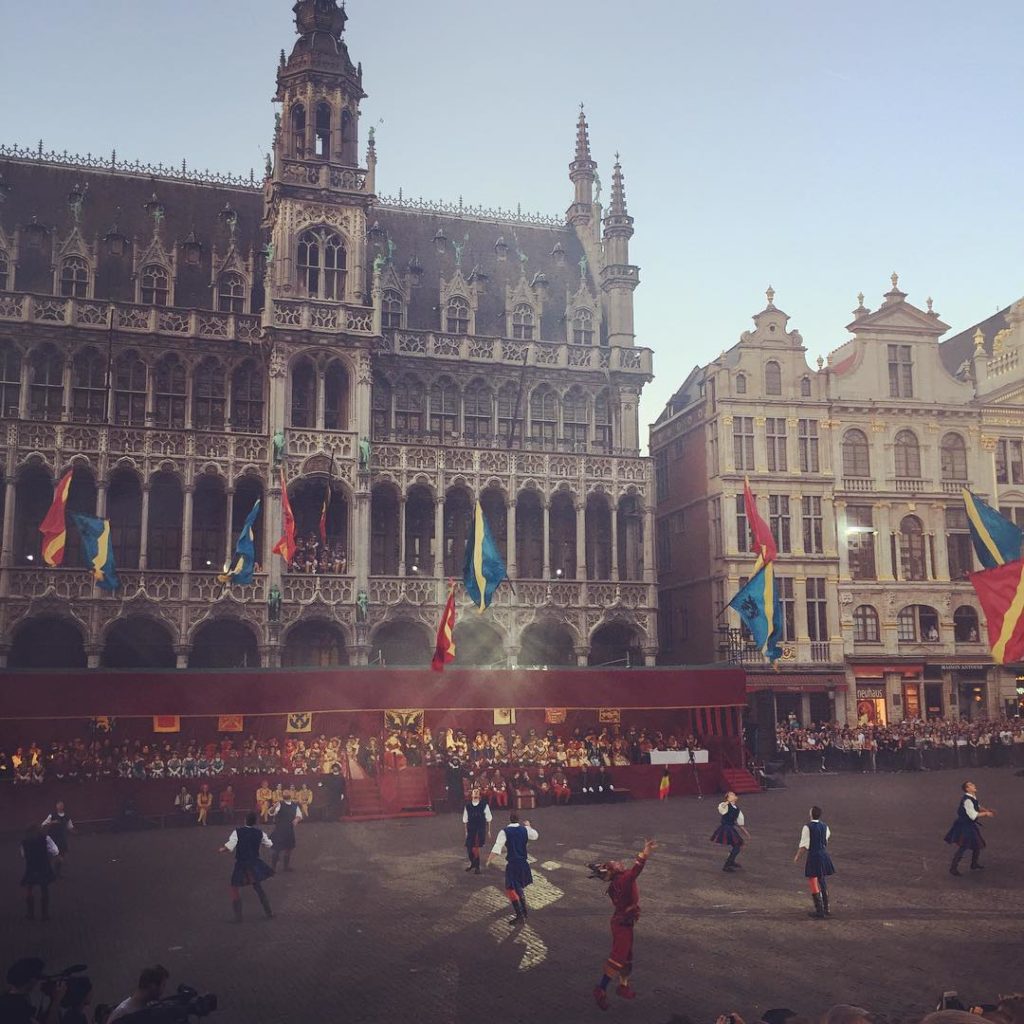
0 160 265 310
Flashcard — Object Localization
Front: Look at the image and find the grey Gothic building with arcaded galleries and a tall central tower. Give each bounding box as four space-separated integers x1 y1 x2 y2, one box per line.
0 0 657 668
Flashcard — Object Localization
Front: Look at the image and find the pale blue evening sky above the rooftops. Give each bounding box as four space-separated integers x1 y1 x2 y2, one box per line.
0 0 1024 438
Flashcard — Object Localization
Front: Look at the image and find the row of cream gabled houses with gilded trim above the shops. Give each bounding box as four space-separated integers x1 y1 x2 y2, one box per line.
651 274 1024 745
